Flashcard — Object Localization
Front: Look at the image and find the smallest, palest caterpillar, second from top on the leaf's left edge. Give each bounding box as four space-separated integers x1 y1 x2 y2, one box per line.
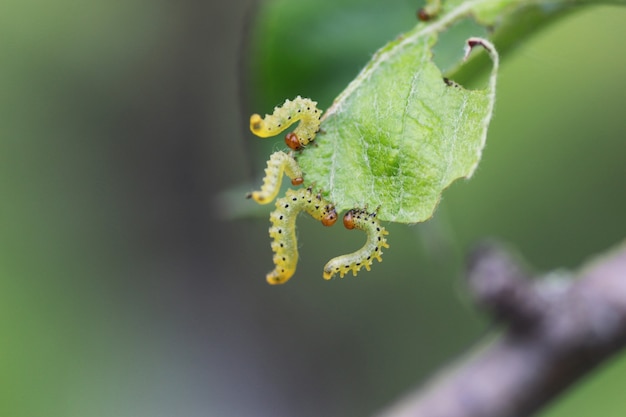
246 151 304 204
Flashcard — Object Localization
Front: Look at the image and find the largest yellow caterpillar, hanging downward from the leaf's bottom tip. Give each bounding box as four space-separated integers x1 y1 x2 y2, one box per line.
266 188 337 284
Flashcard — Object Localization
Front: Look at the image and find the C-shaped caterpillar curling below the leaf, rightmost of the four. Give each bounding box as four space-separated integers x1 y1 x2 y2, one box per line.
324 209 389 279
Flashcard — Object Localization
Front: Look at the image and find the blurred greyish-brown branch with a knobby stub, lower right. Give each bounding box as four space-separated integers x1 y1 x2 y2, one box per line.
379 242 626 417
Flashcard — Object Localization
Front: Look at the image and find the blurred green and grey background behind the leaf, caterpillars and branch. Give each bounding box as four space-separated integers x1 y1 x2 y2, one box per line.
0 0 626 417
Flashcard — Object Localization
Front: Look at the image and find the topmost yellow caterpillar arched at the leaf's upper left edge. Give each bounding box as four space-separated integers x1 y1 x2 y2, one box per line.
250 96 322 150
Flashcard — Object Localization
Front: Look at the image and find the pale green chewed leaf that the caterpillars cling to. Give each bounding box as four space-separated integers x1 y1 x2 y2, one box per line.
298 30 498 223
